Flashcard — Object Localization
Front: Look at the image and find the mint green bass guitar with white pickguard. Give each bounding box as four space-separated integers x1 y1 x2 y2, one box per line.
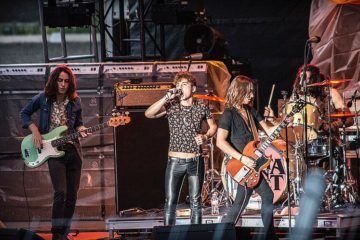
21 116 130 168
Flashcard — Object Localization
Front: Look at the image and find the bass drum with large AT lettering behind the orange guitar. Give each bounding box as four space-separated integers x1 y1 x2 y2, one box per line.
221 139 295 210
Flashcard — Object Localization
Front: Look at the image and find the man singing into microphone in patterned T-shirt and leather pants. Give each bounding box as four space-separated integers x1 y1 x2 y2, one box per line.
145 72 217 226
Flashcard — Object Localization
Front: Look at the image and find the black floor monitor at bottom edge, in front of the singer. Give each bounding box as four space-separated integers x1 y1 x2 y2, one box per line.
152 223 236 240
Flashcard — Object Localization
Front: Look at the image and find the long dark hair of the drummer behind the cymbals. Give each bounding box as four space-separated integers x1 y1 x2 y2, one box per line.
293 64 325 98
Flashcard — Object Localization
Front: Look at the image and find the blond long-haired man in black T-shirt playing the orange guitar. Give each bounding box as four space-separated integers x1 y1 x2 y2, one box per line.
216 75 277 239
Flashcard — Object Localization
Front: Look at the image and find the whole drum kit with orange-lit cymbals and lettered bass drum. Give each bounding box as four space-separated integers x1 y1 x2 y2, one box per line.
194 80 360 210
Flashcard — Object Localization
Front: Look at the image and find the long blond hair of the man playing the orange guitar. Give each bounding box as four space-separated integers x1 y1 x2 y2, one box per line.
225 75 253 108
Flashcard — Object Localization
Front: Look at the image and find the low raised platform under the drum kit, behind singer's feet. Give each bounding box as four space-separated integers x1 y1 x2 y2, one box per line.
106 208 360 239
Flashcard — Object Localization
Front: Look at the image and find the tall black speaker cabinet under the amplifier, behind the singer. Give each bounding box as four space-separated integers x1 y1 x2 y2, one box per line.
115 110 169 212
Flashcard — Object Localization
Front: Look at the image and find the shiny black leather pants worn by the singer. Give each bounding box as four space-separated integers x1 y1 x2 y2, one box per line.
164 156 204 226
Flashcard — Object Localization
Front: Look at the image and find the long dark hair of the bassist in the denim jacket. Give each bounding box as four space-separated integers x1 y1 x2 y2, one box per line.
45 64 77 101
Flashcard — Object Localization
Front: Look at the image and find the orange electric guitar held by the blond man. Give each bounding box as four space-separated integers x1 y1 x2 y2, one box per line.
226 100 305 188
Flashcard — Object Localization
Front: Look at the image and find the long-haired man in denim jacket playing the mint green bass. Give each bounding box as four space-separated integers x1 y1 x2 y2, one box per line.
20 65 87 240
